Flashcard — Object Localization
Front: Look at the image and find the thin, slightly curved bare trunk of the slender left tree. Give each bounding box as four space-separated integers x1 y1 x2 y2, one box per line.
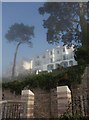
11 42 21 79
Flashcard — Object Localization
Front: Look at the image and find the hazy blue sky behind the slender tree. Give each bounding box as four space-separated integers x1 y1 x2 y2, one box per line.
2 2 57 75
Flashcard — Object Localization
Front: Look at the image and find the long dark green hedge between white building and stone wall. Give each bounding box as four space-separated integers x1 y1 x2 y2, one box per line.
2 65 85 94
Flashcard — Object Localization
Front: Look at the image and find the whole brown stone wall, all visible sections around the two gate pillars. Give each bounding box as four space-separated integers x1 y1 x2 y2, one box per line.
3 66 89 118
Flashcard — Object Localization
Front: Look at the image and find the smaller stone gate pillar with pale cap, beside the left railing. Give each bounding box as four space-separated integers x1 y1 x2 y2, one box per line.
21 90 34 118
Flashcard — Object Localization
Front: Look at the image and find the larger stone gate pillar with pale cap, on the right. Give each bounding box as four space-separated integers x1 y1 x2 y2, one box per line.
57 86 72 117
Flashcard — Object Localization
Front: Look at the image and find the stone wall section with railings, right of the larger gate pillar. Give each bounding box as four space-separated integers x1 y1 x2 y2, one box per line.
72 66 89 116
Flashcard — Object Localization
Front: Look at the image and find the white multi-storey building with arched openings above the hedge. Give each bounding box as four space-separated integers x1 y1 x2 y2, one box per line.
30 46 77 71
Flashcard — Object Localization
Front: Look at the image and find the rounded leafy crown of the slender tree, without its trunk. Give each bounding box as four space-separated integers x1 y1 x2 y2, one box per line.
5 23 34 44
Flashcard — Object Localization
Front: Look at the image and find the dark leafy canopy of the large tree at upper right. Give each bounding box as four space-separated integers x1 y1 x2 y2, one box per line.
39 2 89 45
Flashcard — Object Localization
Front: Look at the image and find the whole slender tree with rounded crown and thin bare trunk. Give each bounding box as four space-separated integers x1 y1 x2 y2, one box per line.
5 23 34 78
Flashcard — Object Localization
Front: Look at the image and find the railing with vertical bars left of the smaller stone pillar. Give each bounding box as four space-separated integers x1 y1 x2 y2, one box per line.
0 100 26 119
